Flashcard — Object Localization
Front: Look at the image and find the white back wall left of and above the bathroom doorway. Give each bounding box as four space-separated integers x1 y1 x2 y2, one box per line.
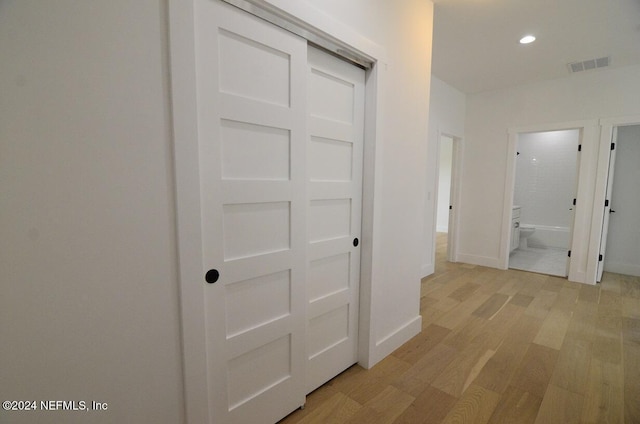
459 62 640 274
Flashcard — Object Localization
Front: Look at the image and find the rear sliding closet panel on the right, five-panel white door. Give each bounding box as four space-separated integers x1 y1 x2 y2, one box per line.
306 47 365 392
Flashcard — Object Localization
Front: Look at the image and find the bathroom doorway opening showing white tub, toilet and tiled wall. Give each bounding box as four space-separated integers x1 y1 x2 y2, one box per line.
508 129 580 277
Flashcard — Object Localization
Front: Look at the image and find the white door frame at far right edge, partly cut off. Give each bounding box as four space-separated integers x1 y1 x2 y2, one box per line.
587 115 640 284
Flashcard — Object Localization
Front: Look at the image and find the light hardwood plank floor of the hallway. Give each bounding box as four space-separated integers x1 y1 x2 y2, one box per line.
281 235 640 424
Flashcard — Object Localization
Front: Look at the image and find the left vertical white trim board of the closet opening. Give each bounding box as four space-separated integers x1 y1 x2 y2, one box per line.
169 0 210 423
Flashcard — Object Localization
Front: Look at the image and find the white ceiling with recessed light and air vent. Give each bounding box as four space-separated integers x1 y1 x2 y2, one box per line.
432 0 640 93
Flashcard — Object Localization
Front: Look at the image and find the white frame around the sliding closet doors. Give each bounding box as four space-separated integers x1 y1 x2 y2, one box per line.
167 0 387 423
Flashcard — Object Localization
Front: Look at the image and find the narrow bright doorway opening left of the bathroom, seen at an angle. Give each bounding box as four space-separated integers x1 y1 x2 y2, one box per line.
434 134 461 266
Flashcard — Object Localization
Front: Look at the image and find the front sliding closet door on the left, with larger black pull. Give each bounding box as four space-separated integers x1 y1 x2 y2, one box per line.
195 0 308 424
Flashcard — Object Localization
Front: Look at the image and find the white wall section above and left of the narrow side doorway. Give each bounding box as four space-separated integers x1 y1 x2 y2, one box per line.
422 75 466 277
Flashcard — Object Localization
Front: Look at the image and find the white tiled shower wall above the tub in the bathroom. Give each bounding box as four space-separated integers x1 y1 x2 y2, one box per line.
514 130 580 228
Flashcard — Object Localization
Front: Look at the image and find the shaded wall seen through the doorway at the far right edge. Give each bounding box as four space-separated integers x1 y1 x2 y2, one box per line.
604 125 640 276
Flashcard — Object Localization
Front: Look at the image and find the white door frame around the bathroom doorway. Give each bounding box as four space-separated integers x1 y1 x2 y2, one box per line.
498 120 598 282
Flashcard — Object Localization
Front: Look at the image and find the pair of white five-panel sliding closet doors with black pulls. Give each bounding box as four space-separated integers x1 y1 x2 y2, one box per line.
189 0 364 424
